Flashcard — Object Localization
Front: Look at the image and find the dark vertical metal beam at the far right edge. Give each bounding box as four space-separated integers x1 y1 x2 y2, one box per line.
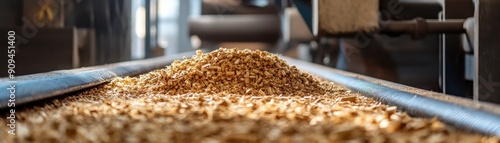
474 0 500 103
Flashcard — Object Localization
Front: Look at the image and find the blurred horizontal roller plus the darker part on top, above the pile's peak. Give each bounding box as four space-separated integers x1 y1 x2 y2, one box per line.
189 0 281 44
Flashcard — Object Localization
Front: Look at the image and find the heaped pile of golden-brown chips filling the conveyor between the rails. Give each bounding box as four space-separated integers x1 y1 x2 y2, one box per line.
0 49 499 143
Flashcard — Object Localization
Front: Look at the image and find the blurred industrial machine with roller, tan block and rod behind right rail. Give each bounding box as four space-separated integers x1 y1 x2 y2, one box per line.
190 0 500 103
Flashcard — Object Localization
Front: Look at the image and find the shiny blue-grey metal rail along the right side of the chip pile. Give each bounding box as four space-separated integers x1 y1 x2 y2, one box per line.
282 57 500 137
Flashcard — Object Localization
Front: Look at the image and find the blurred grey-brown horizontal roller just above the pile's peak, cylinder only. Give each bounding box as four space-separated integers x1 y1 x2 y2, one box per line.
189 15 281 42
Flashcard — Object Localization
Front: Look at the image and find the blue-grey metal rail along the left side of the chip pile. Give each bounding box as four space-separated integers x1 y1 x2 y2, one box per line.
0 52 195 109
